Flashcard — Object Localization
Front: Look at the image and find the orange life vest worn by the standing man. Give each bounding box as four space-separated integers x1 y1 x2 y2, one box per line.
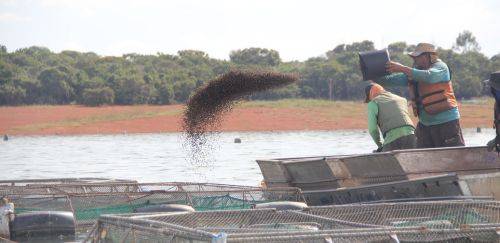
408 80 458 116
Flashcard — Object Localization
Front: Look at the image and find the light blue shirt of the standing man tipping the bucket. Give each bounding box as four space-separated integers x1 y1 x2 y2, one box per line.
376 59 460 126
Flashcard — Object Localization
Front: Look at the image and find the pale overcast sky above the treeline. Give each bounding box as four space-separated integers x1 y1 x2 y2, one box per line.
0 0 500 61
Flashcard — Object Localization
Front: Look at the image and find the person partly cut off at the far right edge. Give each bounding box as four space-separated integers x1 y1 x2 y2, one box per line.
485 71 500 153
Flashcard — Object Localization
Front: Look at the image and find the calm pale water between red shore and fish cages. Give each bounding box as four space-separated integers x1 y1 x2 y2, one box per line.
0 129 494 185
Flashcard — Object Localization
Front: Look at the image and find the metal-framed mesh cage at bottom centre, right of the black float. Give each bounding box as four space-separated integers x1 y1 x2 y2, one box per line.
94 209 360 242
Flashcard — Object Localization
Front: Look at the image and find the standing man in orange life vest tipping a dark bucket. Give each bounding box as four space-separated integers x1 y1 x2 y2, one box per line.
377 43 465 148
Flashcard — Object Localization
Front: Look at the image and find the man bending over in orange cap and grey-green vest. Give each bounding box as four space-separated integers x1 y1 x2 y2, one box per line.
365 83 417 152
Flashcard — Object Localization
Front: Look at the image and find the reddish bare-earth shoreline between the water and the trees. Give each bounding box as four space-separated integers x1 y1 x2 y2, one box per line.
0 99 493 136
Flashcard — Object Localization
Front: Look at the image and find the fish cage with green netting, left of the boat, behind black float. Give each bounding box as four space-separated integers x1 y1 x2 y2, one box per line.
1 182 304 227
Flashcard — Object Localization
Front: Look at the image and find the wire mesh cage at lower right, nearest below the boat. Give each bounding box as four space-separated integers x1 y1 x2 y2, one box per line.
298 200 500 229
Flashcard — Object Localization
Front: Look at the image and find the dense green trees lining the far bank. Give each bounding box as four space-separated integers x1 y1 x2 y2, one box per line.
0 31 500 106
